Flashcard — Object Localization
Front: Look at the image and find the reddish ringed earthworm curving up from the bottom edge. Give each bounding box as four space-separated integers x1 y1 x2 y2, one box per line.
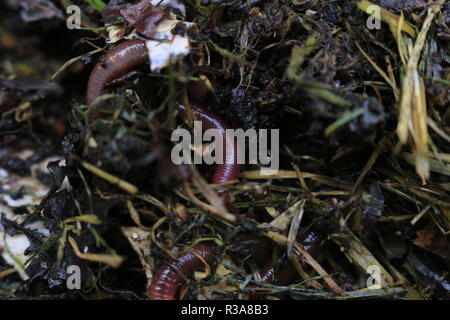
147 244 214 300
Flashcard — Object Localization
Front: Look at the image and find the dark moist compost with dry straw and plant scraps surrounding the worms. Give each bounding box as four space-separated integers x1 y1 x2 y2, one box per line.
0 0 450 300
